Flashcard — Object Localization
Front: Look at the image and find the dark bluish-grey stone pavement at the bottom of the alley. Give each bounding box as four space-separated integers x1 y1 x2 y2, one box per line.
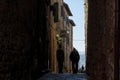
38 73 88 80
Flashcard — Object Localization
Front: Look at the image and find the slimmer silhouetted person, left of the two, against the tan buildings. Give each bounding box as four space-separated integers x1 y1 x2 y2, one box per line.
57 45 64 73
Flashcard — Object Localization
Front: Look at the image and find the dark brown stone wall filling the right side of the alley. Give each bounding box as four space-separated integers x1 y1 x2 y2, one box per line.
86 0 120 80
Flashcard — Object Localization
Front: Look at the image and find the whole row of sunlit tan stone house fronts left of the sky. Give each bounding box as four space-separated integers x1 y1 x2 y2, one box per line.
49 0 74 73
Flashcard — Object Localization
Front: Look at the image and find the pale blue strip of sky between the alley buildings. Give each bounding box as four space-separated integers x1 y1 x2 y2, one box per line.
64 0 85 54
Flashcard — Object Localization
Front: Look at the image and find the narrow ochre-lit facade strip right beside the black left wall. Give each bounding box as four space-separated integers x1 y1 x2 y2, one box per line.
49 0 58 72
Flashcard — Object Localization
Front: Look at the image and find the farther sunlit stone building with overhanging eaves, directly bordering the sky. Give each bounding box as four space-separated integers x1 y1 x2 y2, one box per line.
63 2 75 73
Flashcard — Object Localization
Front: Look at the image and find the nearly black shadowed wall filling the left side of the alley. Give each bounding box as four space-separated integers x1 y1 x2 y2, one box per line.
0 0 48 80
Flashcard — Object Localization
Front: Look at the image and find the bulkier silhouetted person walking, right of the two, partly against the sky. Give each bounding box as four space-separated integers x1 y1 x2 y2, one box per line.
70 48 80 73
